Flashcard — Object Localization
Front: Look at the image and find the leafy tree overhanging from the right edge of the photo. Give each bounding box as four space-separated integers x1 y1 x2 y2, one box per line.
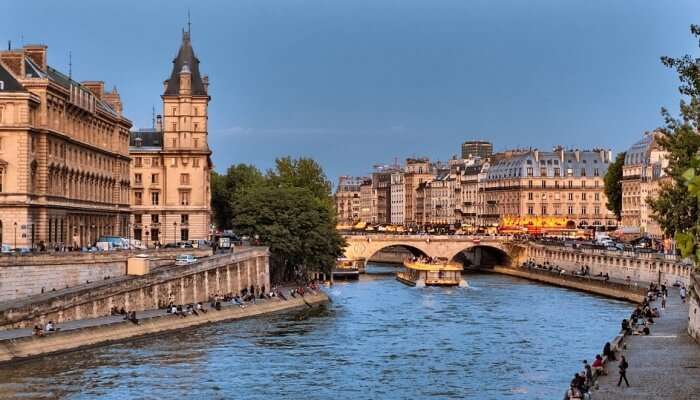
649 25 700 236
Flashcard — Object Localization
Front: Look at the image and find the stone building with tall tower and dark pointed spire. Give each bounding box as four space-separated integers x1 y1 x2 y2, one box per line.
129 31 212 245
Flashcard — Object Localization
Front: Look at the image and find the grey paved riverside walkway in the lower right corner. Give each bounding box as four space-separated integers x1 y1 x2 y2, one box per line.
589 288 700 400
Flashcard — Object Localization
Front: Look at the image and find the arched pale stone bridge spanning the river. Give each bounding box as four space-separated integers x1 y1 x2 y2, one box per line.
345 235 527 265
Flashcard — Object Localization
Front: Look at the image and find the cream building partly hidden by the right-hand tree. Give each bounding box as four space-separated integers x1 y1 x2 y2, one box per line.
621 132 670 239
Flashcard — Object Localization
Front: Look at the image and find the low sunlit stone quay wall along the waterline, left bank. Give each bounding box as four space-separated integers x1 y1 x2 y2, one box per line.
0 292 328 364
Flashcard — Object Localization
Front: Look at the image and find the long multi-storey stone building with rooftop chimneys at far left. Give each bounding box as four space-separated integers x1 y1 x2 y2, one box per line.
0 45 131 248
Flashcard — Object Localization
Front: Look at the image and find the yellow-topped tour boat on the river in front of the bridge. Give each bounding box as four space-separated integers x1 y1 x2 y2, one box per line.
396 259 467 287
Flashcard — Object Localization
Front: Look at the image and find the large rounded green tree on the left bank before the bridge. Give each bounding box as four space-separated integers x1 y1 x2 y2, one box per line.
233 185 344 282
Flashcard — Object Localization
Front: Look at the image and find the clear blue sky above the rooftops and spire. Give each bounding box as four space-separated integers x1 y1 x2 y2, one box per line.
0 0 700 181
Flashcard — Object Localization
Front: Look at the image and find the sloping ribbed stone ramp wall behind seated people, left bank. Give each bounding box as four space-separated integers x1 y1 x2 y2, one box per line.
0 247 270 330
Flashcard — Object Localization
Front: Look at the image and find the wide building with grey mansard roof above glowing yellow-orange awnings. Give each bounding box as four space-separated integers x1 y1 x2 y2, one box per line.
484 148 617 229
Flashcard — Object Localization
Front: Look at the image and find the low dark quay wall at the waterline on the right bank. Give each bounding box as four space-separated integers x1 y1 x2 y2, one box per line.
490 266 646 303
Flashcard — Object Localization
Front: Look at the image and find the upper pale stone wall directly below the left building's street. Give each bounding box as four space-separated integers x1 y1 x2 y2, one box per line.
0 249 211 302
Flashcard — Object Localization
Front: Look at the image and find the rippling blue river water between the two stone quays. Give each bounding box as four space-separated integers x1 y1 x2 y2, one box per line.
0 266 632 400
